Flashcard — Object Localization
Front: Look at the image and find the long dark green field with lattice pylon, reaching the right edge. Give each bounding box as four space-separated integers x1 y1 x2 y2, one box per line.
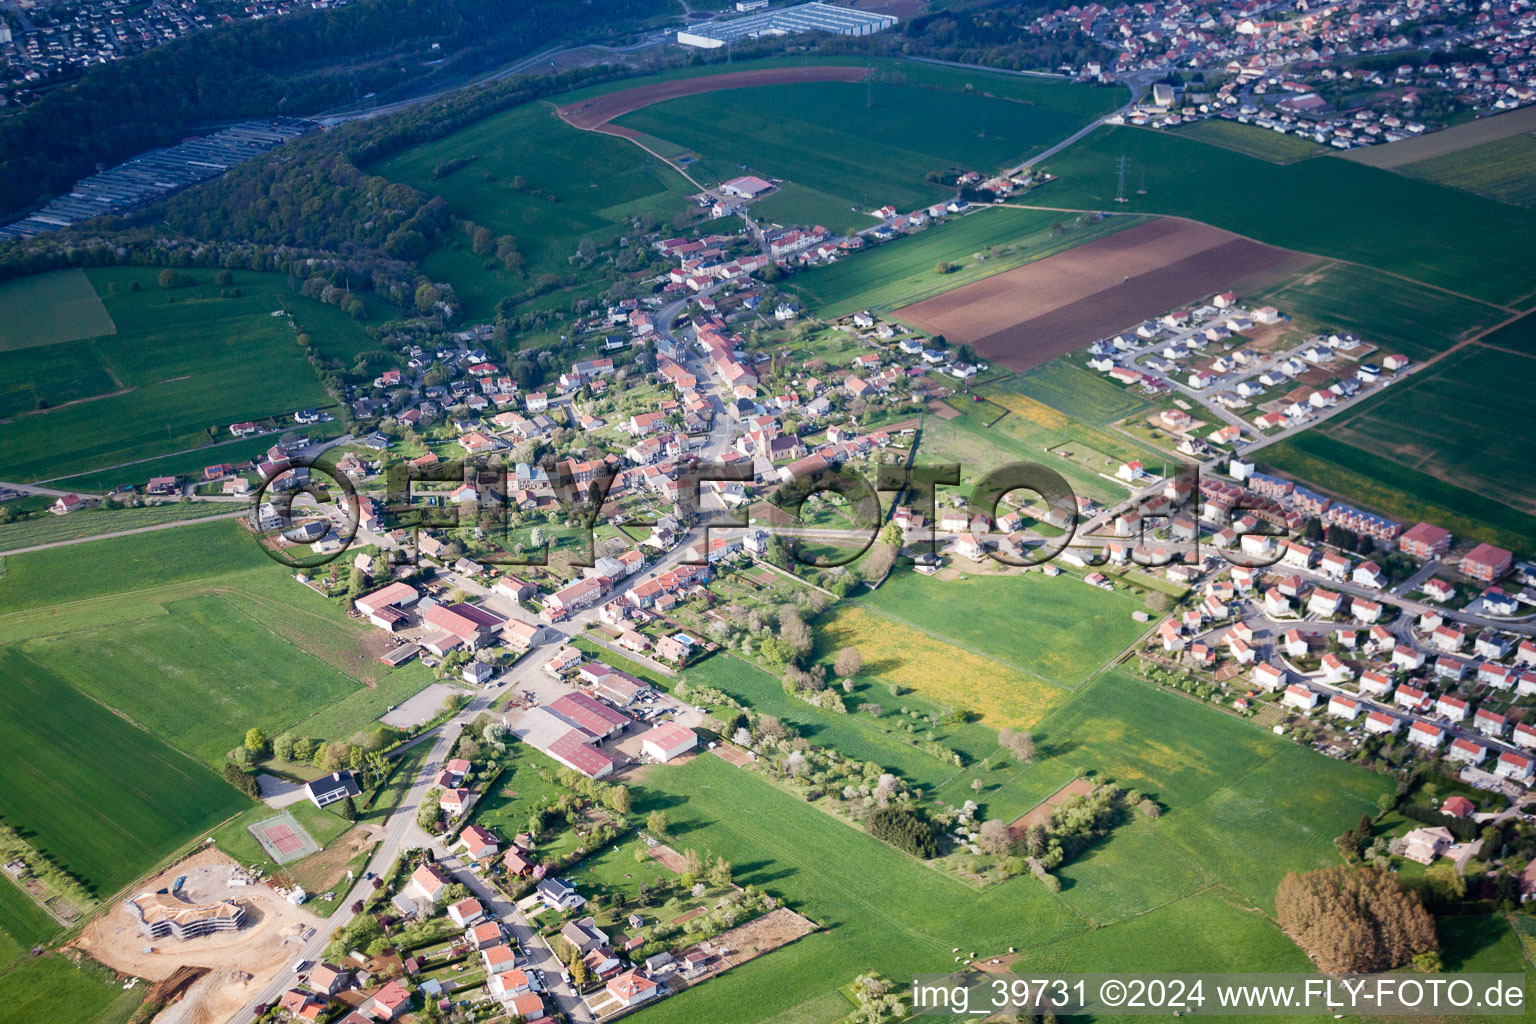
1031 127 1536 302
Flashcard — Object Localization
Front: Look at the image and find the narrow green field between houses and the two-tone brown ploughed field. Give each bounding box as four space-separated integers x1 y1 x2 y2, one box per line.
791 207 1141 318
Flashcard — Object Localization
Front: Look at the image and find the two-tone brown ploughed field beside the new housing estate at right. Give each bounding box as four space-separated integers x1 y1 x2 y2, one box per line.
894 218 1295 370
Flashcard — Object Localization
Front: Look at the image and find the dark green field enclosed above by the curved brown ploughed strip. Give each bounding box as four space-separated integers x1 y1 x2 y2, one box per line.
616 64 1123 230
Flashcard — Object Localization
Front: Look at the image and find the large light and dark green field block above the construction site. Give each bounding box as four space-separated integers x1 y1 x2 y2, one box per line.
0 522 430 894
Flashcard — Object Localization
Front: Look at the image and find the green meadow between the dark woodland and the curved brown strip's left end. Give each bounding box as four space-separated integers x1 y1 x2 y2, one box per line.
369 103 694 316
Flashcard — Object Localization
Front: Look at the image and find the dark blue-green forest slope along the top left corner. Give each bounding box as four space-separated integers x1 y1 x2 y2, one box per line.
0 0 667 216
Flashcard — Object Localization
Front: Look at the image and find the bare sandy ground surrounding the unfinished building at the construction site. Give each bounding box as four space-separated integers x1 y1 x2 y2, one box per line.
75 847 318 1024
